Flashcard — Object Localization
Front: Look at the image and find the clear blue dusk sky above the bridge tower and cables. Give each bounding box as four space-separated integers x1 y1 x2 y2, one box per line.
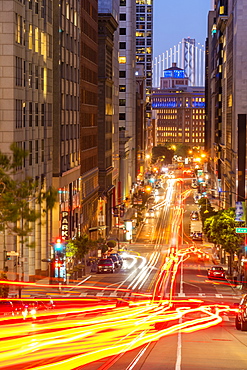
153 0 212 57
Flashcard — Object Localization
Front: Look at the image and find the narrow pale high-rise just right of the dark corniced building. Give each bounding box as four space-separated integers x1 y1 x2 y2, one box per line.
119 0 137 201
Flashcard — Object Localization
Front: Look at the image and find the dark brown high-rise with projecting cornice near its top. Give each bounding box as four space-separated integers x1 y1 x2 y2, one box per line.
98 0 119 237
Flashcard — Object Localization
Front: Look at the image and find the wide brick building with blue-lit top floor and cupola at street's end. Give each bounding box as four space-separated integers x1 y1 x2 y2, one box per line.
152 63 205 148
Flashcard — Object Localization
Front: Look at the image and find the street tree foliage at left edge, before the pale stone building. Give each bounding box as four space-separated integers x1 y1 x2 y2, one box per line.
0 144 57 247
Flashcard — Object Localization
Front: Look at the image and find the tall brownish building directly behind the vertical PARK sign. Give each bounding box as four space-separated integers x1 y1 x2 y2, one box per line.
51 0 82 249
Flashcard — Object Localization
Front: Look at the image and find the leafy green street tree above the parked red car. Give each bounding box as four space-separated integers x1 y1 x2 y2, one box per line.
204 208 243 271
